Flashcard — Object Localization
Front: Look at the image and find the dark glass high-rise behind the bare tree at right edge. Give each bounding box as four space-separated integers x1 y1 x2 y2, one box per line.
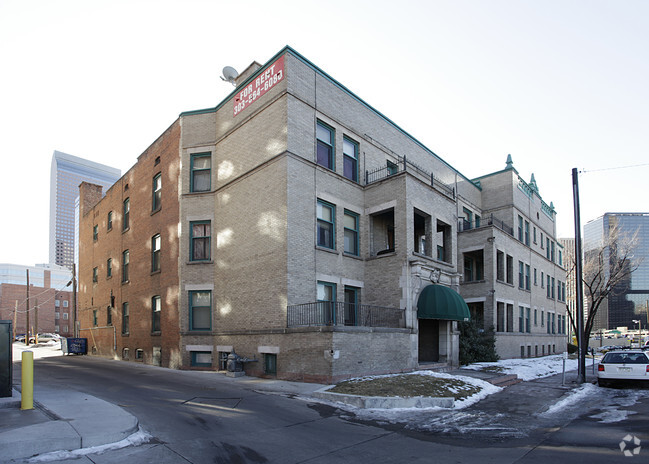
584 213 649 330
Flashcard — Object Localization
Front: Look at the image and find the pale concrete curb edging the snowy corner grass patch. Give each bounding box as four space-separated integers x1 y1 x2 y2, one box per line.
313 385 455 409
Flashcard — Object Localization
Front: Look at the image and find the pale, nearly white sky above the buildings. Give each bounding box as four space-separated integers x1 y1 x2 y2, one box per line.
0 0 649 265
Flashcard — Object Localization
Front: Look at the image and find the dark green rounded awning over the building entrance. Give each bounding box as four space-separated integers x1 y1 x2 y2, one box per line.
417 285 471 321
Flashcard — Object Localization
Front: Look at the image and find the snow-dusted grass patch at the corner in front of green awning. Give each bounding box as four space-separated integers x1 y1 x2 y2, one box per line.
329 374 481 400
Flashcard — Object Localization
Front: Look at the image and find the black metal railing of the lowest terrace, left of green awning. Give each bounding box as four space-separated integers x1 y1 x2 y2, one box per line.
286 301 406 329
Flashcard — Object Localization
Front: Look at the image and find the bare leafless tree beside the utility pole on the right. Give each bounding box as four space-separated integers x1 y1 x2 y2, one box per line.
566 225 641 353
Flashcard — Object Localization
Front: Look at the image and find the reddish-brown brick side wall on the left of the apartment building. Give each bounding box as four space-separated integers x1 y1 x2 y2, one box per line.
78 121 180 367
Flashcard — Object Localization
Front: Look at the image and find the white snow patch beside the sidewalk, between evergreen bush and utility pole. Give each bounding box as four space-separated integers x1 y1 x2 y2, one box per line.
462 355 590 380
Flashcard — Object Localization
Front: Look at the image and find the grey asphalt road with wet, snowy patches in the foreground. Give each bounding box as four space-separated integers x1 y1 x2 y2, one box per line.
15 356 649 464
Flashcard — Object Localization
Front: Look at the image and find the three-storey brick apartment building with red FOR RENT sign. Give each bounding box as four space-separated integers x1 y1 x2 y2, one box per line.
79 47 565 382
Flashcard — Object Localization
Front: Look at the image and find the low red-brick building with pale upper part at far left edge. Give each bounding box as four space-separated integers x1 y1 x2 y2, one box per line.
0 264 74 337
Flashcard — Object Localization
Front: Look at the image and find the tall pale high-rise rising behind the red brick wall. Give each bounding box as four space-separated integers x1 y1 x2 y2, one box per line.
49 151 122 269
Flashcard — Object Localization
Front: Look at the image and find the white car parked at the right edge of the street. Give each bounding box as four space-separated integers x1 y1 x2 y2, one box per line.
597 348 649 387
